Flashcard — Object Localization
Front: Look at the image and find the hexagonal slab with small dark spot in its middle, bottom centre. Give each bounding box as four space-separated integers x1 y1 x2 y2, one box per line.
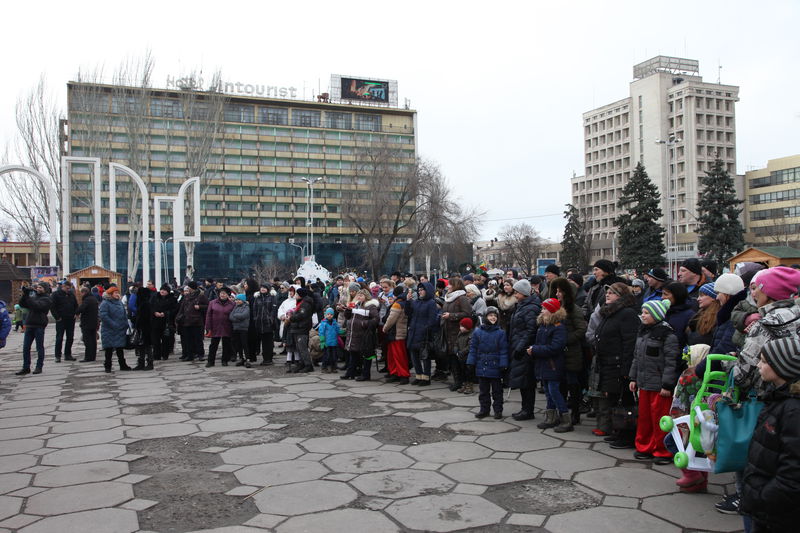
386 494 506 531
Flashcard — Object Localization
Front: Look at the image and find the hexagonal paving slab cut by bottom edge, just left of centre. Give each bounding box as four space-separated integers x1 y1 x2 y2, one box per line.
277 509 400 533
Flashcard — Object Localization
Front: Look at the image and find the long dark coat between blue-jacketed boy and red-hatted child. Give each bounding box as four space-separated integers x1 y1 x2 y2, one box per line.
508 294 542 389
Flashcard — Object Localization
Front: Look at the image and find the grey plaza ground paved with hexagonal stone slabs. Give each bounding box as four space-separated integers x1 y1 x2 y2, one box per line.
0 327 741 533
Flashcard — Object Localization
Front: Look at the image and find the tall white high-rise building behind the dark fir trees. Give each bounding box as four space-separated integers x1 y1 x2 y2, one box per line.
571 56 742 272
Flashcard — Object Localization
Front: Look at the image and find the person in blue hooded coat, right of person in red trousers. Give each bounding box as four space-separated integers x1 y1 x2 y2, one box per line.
405 281 439 386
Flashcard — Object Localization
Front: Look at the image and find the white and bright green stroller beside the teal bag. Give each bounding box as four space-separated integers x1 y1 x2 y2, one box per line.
659 354 738 472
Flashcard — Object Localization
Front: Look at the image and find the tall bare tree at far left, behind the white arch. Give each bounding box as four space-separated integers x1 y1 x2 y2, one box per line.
0 76 63 265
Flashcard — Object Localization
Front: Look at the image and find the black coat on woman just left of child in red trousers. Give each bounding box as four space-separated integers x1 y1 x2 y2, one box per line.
593 301 641 394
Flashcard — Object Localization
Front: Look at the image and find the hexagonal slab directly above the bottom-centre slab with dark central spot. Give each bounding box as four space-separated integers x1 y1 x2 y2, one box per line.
350 469 455 500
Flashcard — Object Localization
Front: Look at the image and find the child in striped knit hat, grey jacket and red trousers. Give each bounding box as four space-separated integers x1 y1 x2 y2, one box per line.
628 300 681 465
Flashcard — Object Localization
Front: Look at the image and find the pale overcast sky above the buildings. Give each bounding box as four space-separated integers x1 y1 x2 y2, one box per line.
0 0 800 240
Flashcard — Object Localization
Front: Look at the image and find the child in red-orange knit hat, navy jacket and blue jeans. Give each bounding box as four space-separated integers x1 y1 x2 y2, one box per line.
528 298 573 433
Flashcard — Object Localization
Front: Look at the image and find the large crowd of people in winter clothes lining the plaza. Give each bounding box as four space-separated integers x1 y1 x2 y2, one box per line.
7 259 800 531
